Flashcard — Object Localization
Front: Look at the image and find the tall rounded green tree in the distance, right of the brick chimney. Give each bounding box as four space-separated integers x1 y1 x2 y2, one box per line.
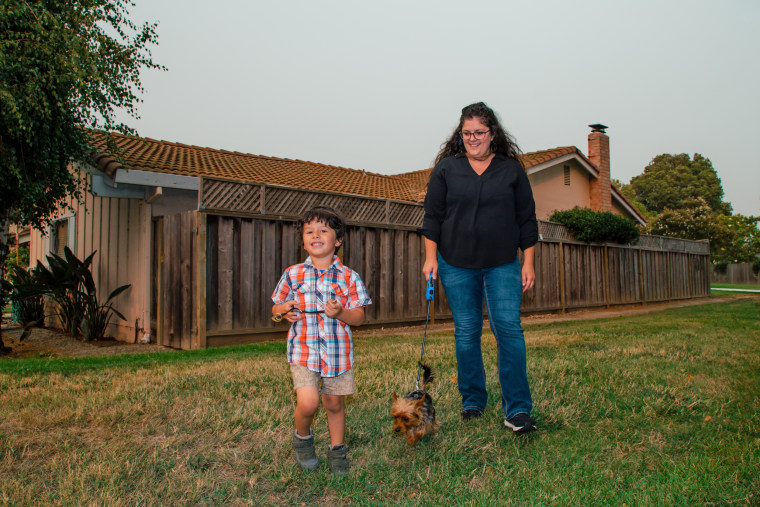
621 153 731 215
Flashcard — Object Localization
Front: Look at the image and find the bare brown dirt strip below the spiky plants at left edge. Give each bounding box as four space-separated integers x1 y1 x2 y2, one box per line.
0 325 172 360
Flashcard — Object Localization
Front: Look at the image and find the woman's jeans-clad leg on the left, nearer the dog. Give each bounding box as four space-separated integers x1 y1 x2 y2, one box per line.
438 255 488 412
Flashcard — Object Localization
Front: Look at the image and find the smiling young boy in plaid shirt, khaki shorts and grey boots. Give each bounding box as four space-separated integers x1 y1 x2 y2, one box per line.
272 206 372 474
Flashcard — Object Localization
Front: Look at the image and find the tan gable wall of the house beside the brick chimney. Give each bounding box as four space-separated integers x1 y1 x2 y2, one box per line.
528 161 590 220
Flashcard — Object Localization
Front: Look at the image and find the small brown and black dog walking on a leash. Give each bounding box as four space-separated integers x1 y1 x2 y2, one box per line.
391 363 438 445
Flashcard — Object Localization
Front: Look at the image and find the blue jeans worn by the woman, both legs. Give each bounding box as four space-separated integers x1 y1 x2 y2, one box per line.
438 254 533 418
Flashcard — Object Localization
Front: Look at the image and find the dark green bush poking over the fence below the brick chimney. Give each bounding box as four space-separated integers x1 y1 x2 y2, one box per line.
549 206 639 245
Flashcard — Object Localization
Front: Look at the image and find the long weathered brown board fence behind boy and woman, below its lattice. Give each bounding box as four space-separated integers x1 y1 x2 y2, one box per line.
156 211 710 349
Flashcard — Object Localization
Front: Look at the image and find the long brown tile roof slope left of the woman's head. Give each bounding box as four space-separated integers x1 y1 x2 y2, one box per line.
93 132 419 202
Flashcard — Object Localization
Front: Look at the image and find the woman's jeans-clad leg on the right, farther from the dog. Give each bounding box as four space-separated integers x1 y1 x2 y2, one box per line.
483 259 533 418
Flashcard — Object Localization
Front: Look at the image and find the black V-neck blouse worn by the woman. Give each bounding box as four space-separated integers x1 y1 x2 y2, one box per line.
418 153 538 268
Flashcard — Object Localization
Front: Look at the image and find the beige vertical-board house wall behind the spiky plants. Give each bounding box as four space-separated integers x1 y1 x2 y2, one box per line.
30 173 151 342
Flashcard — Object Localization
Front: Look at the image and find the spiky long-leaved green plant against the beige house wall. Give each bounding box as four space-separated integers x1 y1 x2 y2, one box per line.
31 247 131 341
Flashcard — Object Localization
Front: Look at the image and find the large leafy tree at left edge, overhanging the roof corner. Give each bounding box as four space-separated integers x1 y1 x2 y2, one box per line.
0 0 163 356
